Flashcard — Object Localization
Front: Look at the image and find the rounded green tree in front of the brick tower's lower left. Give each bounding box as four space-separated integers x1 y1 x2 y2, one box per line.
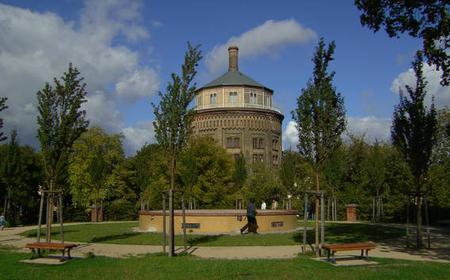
178 137 234 209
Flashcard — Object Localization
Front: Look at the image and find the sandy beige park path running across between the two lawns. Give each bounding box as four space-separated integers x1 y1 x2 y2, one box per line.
0 222 450 263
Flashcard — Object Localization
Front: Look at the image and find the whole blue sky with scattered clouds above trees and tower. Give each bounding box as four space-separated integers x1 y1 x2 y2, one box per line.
0 0 450 155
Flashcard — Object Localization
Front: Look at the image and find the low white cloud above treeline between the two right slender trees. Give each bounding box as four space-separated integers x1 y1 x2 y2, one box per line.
347 116 392 142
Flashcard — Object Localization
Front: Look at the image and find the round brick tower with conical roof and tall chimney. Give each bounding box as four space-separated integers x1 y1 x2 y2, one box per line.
192 46 284 166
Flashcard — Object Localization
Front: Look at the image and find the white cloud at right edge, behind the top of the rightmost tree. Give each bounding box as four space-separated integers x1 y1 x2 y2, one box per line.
391 63 450 108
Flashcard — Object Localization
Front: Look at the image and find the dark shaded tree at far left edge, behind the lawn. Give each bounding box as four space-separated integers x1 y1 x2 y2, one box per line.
0 130 43 226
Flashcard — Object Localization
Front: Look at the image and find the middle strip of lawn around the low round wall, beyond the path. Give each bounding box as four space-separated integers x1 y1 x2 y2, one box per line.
23 222 404 246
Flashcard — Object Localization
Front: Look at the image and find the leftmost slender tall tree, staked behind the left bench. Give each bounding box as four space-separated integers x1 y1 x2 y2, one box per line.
37 64 89 242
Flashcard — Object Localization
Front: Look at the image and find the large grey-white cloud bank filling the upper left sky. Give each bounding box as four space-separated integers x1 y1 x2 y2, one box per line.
0 0 159 149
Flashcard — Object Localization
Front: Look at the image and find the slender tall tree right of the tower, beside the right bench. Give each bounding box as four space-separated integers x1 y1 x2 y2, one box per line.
292 38 345 254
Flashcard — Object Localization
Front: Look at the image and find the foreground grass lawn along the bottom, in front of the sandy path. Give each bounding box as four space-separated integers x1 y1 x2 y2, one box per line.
0 250 450 280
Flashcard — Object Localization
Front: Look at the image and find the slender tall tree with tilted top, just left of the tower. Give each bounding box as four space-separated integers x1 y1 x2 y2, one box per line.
152 43 202 256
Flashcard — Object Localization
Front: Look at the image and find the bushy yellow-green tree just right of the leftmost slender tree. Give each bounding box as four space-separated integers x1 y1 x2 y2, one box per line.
69 127 124 221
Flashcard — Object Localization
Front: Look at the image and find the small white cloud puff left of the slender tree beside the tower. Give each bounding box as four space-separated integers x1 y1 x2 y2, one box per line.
116 69 159 100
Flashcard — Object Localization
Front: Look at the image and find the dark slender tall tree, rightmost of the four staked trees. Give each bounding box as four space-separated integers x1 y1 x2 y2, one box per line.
391 51 436 248
